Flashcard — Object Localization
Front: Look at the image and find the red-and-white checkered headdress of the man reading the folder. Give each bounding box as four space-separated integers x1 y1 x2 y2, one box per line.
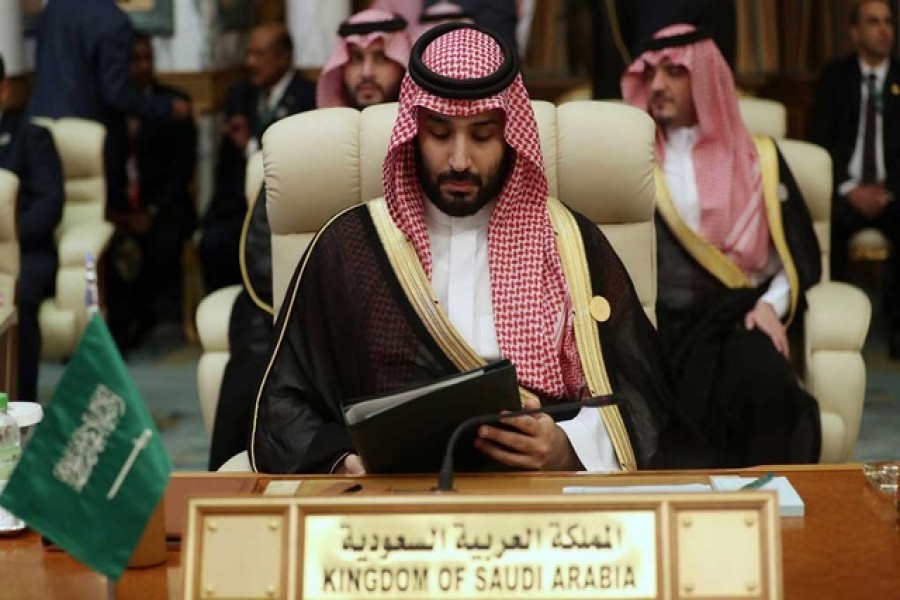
384 28 584 398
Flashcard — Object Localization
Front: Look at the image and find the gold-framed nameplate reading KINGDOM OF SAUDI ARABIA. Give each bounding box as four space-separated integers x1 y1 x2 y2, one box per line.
183 492 783 600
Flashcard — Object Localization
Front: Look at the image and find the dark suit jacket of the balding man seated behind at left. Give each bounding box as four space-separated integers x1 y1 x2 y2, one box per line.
204 73 316 223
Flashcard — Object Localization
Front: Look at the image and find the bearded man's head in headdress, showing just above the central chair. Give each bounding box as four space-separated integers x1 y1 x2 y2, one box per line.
316 8 411 110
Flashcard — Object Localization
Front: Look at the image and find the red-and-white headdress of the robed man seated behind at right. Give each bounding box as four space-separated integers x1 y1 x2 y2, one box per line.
622 25 769 276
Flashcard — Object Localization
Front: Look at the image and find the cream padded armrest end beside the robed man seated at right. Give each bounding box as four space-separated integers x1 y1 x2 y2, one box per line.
806 281 872 352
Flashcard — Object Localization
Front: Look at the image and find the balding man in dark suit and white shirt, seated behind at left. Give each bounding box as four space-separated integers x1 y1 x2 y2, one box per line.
200 24 315 292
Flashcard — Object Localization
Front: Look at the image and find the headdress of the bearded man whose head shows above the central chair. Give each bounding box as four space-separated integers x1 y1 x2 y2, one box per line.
316 8 412 108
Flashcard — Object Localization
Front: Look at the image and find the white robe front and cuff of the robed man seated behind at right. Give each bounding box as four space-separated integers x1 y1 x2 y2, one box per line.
663 127 791 318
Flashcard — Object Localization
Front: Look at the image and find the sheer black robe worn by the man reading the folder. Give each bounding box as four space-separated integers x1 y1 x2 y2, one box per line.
250 206 711 473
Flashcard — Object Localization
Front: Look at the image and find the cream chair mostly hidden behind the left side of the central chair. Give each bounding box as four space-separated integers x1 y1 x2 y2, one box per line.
197 152 263 437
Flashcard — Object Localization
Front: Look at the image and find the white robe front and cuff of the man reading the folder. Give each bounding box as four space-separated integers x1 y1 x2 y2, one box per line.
425 201 620 471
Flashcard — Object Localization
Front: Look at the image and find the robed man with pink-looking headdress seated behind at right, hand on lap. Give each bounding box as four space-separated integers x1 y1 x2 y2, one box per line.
622 25 821 467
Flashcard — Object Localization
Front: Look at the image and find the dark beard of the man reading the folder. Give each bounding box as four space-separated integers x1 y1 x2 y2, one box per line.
414 144 515 217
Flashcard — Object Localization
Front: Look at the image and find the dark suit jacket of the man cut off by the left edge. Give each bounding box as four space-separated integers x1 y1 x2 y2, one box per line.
0 113 64 253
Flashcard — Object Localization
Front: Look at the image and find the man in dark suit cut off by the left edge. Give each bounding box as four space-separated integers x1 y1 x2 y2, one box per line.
0 57 63 400
